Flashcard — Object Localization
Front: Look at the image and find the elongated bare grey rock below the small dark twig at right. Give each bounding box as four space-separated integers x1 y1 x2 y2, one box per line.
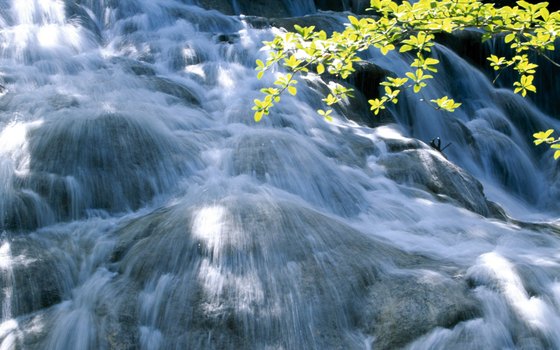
378 149 495 216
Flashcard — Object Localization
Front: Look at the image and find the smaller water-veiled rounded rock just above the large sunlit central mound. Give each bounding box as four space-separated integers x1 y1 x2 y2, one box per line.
228 132 366 216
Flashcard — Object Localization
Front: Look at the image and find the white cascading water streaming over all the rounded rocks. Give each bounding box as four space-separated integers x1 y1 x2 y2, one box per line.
0 0 560 350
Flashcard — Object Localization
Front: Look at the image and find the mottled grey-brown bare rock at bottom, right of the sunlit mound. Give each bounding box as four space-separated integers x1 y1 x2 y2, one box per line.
365 271 481 349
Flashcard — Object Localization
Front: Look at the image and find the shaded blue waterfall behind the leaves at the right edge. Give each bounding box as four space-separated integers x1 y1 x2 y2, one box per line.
371 46 559 215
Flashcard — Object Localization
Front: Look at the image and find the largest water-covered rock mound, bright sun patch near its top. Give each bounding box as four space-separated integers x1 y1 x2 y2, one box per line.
110 193 442 349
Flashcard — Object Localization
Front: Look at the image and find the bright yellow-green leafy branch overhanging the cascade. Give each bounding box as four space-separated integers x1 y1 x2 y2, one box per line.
253 0 560 156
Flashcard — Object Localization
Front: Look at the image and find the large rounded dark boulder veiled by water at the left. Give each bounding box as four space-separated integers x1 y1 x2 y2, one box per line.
15 110 197 224
